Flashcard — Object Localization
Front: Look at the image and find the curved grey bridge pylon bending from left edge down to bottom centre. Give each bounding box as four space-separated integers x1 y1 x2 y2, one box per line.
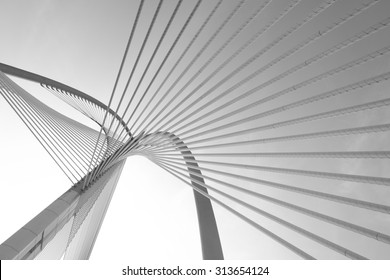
0 63 223 260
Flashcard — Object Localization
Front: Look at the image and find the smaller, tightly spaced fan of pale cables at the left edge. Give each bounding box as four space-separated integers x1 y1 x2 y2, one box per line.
0 73 107 184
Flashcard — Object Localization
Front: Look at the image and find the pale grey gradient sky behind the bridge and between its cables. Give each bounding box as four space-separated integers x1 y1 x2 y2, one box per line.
0 0 390 260
